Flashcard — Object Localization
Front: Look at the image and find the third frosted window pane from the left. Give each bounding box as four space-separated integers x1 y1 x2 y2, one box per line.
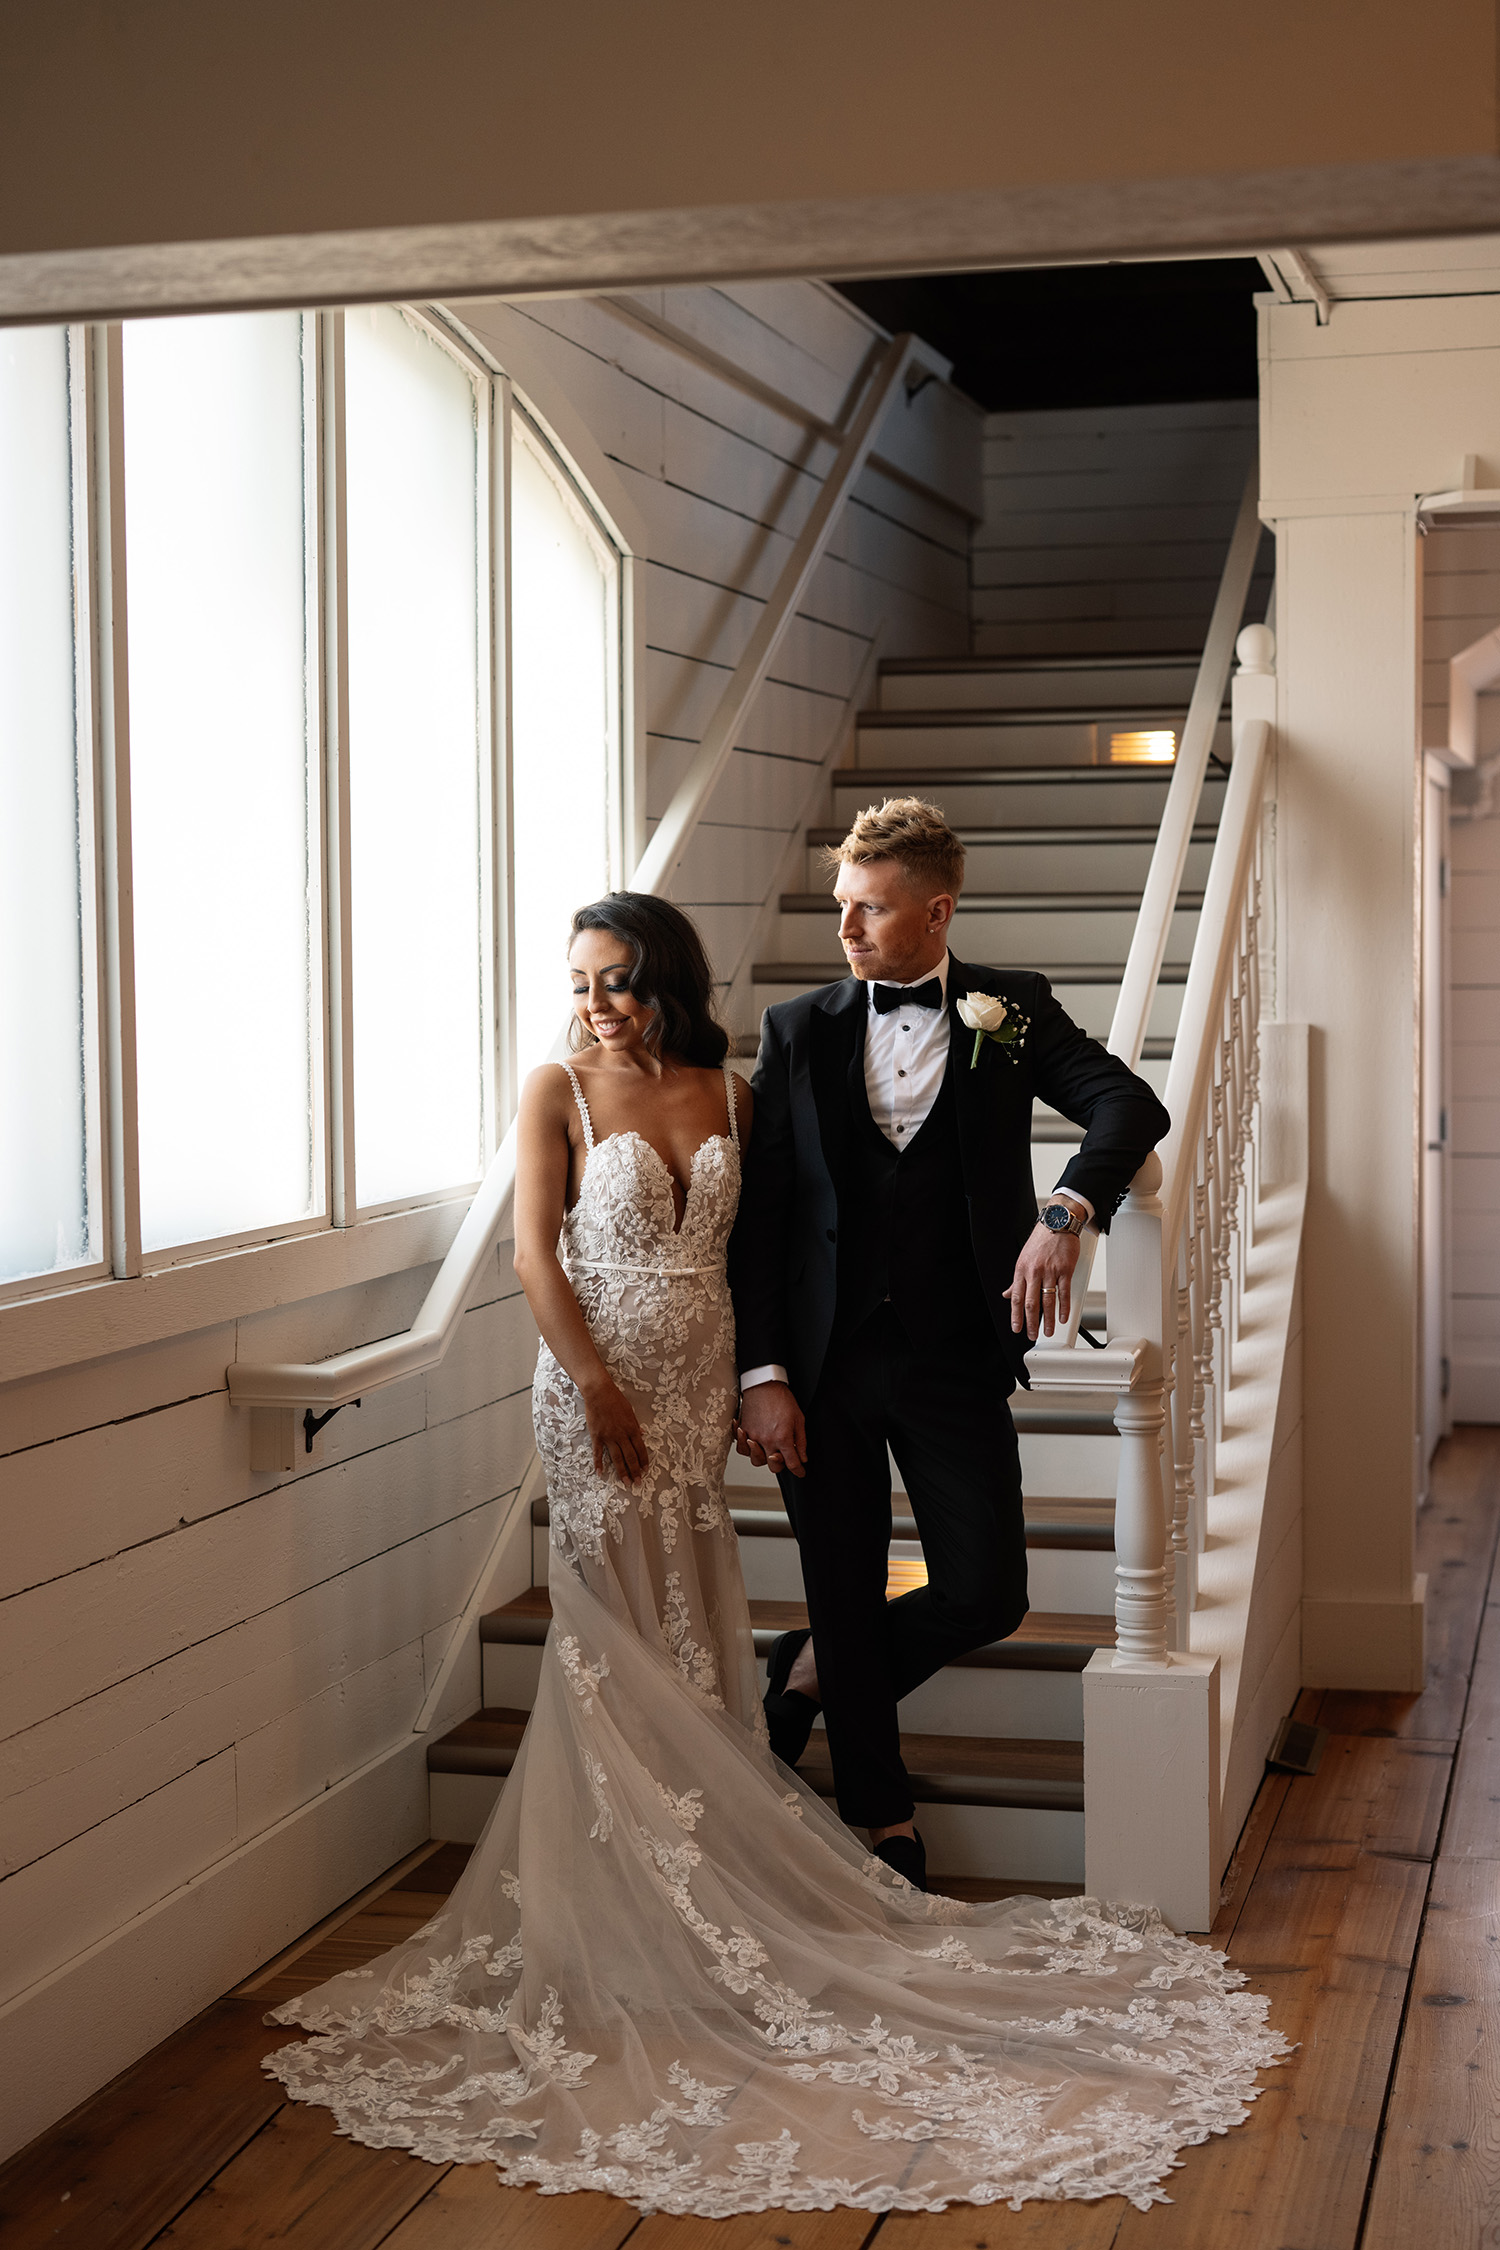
344 306 484 1208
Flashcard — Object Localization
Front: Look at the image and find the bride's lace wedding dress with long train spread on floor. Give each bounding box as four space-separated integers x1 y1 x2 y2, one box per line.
265 1071 1286 2219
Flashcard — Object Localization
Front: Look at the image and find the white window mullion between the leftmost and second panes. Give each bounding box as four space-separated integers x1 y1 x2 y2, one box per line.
88 322 142 1280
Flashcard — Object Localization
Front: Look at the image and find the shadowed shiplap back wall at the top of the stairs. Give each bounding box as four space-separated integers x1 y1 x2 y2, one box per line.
972 398 1271 657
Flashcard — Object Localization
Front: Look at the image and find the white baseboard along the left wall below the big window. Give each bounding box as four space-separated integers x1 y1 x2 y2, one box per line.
0 1735 430 2160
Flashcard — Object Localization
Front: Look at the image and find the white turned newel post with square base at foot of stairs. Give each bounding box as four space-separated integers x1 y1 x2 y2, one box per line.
1084 1157 1219 1931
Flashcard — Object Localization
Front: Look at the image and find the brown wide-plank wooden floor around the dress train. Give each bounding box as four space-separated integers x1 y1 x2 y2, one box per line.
0 1429 1500 2250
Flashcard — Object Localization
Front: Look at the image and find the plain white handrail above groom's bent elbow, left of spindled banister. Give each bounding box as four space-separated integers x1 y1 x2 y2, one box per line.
1106 461 1262 1069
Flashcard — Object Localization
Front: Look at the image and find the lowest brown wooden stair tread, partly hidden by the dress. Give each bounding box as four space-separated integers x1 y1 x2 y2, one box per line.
427 1708 1084 1811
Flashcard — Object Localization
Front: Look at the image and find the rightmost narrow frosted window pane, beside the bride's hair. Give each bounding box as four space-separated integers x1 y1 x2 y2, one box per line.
510 414 618 1073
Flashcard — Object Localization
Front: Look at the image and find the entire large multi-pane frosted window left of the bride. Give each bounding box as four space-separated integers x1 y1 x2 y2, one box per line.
0 306 625 1296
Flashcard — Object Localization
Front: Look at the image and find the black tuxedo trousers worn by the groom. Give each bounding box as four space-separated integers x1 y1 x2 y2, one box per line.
780 1303 1028 1827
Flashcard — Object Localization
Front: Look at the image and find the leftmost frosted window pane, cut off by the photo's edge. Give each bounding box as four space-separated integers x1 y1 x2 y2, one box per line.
0 329 99 1280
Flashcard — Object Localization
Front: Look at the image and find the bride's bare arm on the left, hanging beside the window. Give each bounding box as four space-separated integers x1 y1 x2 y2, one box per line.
515 1067 645 1485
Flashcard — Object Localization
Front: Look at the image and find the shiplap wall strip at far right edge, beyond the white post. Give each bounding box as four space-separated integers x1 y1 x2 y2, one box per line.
1421 517 1500 1422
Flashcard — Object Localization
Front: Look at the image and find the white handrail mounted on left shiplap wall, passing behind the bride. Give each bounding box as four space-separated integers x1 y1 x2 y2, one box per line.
225 335 920 1409
